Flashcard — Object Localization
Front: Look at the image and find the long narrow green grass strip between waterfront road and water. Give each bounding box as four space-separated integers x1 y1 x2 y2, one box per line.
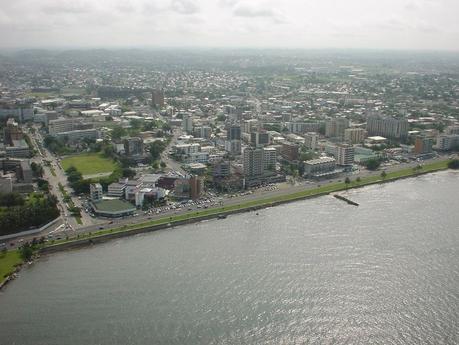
47 161 448 249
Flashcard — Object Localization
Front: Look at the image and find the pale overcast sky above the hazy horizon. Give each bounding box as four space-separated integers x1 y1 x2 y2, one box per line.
0 0 459 51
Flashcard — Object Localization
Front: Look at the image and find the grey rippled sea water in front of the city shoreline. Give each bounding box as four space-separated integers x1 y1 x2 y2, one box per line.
0 172 459 345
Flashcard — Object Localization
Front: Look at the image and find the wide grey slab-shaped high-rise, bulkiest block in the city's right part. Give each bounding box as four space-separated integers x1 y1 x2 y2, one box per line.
367 115 410 139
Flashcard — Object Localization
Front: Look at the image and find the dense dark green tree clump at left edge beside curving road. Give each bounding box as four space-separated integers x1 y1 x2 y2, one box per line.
0 193 59 235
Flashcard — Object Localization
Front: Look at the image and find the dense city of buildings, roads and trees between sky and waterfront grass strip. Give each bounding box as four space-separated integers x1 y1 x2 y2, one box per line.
0 50 459 248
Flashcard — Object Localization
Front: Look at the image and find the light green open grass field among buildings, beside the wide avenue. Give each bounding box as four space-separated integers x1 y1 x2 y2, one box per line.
61 153 117 175
